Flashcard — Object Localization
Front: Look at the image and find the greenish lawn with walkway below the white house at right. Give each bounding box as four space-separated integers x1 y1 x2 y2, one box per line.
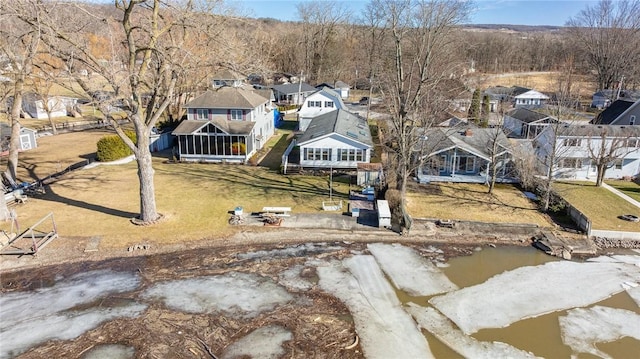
553 181 640 232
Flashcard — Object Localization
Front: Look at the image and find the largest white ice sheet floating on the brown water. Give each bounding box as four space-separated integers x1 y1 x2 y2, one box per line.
429 261 640 334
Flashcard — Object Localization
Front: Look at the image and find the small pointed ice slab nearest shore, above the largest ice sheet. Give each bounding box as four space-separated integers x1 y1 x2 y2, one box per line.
367 243 458 296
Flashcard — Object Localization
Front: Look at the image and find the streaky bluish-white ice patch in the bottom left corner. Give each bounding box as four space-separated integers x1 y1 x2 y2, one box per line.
0 271 146 358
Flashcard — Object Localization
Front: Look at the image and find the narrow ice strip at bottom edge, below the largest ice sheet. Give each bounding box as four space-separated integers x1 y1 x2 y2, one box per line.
407 303 536 359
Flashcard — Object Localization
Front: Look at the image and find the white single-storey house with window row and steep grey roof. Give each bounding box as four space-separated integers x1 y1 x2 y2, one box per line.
288 109 373 170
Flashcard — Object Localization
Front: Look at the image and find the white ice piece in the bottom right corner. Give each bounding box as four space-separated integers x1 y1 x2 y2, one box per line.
558 306 640 358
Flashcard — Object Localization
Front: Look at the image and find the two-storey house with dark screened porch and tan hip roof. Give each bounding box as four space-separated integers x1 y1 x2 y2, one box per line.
172 87 277 163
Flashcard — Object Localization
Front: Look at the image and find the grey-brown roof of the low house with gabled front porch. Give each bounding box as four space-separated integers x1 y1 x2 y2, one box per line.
425 128 511 160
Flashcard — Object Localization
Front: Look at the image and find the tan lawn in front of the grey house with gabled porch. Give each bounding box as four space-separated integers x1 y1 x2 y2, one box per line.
407 183 551 227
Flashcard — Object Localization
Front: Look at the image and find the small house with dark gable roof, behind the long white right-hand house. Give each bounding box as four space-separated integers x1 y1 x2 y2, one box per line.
502 107 559 139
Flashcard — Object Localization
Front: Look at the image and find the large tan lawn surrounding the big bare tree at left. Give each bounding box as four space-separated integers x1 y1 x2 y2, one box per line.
2 131 349 247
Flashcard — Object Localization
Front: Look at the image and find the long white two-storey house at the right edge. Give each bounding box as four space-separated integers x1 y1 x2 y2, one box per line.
535 125 640 180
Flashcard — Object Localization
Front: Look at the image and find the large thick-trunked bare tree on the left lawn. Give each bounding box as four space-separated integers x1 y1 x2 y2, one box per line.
22 0 229 224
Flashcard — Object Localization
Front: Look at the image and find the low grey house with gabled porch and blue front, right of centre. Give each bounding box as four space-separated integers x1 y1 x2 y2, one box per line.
415 127 518 183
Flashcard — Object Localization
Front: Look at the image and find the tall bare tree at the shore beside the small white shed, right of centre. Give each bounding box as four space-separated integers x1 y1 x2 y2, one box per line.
372 0 470 229
